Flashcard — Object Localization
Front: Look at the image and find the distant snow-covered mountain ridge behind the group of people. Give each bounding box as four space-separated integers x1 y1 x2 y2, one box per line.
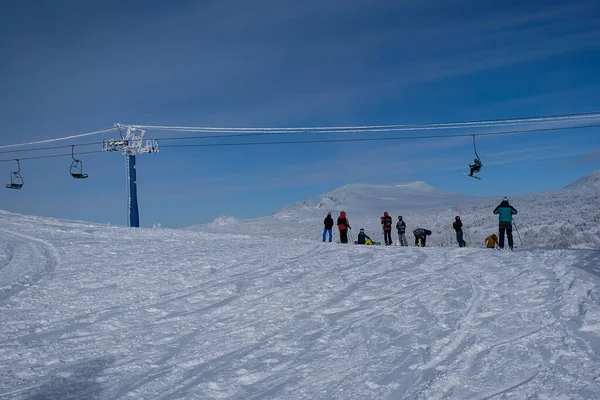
189 170 600 249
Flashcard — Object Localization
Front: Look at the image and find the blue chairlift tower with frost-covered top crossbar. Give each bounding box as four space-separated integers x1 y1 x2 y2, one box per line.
102 124 158 228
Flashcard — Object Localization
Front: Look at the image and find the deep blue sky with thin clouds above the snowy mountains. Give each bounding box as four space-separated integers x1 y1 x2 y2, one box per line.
0 0 600 227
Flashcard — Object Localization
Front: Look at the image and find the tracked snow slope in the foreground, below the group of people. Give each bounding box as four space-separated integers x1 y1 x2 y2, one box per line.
0 216 600 400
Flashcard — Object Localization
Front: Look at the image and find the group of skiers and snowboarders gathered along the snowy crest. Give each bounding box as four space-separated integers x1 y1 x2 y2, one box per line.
323 197 517 250
